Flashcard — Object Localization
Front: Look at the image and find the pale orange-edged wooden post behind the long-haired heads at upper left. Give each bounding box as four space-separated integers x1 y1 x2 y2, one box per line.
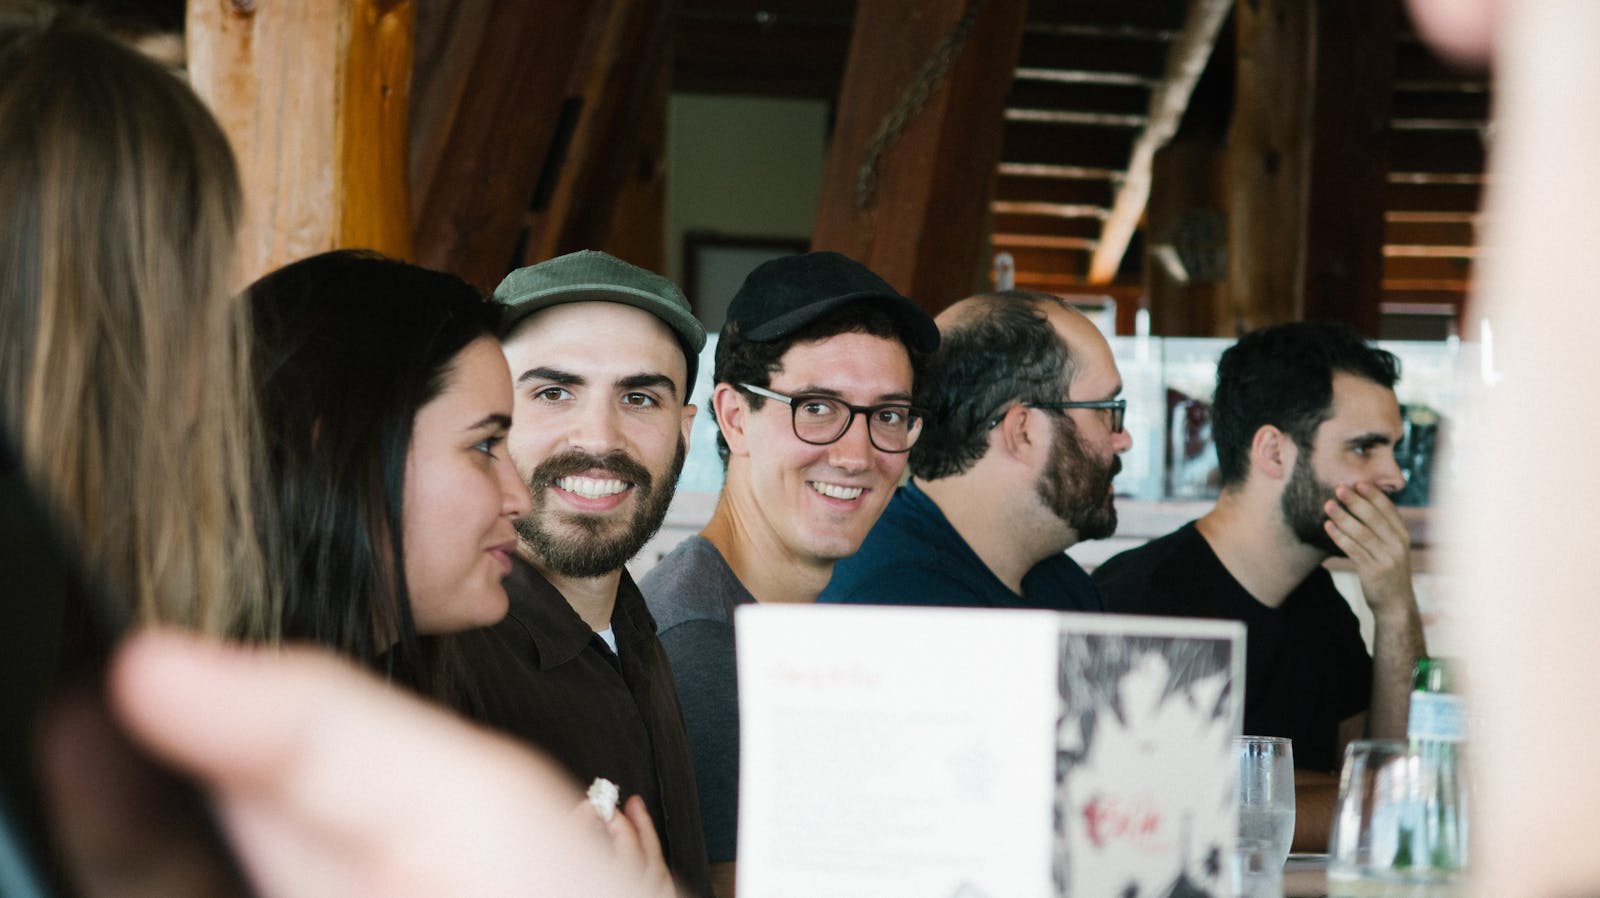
186 0 416 282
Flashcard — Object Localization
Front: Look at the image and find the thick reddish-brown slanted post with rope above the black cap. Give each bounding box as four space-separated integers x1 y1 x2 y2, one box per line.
811 0 1026 312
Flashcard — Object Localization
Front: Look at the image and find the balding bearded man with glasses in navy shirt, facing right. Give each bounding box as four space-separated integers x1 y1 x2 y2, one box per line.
819 291 1133 611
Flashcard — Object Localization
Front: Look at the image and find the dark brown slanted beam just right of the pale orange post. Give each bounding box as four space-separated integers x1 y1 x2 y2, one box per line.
411 0 608 288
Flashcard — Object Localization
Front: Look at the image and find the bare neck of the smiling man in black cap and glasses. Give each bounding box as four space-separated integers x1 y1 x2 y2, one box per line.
701 488 834 603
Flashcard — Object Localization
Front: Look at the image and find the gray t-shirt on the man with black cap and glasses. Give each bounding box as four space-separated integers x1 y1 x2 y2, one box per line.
638 536 755 864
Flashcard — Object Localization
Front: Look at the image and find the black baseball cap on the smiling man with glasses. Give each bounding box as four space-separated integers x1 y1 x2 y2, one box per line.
728 251 939 352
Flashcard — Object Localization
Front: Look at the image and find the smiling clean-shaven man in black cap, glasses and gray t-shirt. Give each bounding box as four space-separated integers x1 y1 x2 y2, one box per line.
640 253 939 895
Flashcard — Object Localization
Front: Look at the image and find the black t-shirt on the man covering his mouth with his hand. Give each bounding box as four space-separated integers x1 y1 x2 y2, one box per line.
1094 522 1373 770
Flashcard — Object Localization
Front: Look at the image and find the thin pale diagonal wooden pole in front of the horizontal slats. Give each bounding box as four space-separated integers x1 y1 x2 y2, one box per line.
1090 0 1232 283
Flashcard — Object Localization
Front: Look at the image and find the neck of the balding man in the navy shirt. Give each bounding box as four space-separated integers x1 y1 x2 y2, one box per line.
912 463 1077 595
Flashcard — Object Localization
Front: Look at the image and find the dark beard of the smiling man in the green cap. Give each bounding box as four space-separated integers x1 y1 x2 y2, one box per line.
515 437 688 578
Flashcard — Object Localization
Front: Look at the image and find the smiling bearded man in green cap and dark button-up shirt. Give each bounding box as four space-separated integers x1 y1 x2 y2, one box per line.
462 251 710 895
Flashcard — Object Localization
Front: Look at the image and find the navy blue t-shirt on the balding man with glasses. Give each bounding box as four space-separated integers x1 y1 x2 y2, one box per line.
818 483 1104 611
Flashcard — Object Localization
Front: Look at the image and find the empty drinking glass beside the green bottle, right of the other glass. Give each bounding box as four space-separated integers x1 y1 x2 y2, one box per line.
1328 740 1461 898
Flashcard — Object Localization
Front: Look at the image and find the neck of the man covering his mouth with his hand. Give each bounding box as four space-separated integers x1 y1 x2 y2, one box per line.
1195 487 1328 608
